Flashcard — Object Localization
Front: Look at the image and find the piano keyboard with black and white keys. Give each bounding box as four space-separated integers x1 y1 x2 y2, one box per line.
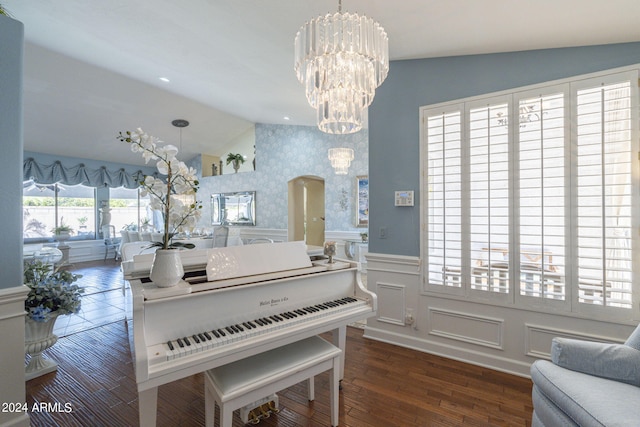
150 297 368 361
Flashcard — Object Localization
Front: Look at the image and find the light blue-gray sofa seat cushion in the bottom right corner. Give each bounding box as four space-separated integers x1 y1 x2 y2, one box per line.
531 360 640 427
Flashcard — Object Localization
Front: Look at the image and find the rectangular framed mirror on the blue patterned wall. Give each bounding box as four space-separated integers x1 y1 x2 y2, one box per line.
211 191 256 225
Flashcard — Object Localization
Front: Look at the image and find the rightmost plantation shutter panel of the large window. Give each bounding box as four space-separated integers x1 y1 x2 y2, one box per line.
576 81 637 308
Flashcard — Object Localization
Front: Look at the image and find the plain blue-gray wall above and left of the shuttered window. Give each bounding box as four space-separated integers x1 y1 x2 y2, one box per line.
369 42 640 256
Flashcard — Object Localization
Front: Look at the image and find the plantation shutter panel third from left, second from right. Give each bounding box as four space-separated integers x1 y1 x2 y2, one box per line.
517 92 569 301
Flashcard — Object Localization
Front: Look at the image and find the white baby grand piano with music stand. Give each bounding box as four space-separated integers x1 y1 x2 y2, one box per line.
122 242 377 426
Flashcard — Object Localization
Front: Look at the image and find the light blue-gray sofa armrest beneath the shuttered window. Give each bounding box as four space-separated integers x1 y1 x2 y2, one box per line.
551 338 640 386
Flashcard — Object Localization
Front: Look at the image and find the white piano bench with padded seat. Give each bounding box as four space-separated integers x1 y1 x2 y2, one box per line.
204 337 342 427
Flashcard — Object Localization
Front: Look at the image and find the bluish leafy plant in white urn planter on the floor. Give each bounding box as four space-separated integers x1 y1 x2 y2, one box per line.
24 260 84 380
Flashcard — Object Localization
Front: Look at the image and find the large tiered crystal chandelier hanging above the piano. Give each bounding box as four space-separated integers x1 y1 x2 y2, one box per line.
294 0 389 134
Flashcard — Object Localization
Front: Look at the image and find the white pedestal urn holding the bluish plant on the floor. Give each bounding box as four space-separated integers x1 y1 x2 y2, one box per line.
24 315 58 381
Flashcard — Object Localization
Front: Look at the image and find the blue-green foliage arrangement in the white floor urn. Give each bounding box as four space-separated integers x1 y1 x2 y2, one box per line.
24 261 84 322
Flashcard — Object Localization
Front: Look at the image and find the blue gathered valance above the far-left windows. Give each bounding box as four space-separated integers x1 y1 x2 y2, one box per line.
23 157 154 188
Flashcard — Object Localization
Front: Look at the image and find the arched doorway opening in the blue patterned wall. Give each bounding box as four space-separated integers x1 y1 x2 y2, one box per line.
288 176 325 246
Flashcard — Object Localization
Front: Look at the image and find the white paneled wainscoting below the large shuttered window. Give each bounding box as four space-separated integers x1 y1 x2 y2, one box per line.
365 253 634 377
